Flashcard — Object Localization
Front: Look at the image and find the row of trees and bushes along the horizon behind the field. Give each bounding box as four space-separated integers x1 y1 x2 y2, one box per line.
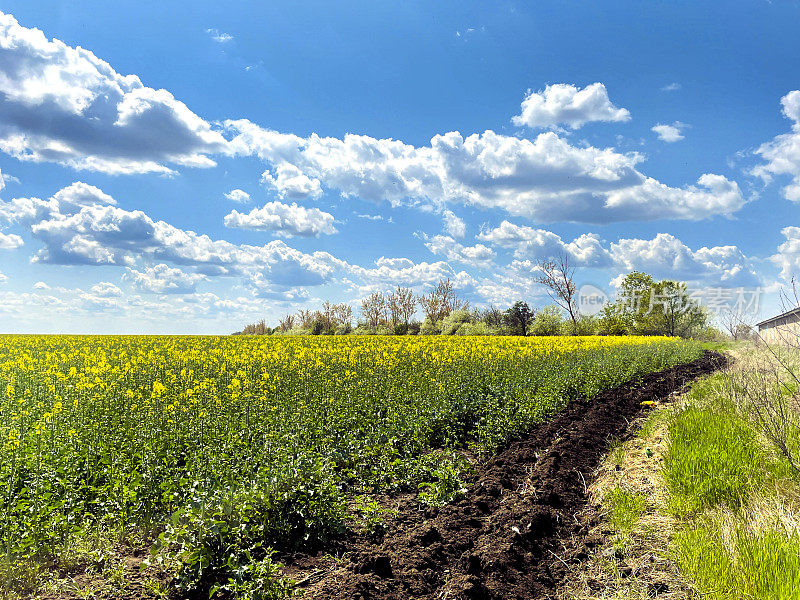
234 256 724 339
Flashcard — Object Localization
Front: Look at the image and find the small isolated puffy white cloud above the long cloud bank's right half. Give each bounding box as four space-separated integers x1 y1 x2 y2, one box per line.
511 83 631 129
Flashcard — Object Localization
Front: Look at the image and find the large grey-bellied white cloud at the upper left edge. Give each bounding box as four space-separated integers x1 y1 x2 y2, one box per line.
0 13 226 174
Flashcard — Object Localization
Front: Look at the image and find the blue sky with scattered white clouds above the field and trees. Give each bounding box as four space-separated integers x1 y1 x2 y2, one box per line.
0 0 800 333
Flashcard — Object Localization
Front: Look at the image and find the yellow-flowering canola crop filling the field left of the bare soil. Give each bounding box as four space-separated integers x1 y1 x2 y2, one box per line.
0 336 701 580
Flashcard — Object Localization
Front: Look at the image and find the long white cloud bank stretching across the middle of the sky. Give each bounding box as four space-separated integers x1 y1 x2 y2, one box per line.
226 120 745 223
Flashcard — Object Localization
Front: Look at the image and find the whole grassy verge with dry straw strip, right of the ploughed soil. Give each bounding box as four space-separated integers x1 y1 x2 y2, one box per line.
562 345 800 600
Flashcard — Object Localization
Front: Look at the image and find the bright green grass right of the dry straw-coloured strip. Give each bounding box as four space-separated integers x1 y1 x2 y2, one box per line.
663 350 800 600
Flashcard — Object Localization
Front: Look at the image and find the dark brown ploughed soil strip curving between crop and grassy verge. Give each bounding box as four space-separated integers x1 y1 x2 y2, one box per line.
284 352 726 600
